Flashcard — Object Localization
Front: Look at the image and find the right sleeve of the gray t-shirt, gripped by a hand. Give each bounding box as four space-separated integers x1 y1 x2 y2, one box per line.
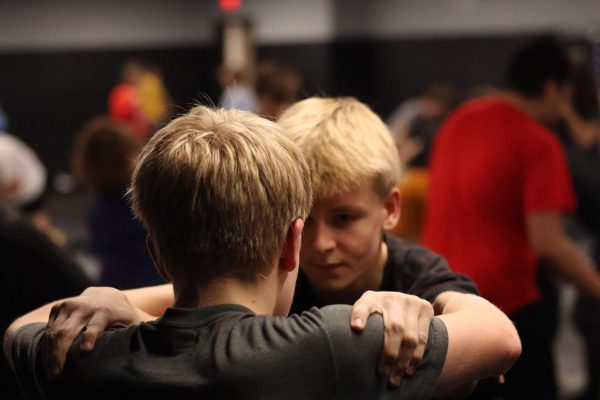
321 306 448 400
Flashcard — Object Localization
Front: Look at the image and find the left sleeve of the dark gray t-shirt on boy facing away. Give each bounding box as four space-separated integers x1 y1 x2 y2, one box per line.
11 323 46 399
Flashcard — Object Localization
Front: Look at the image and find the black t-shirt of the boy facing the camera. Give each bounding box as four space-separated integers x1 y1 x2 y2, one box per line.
291 234 479 313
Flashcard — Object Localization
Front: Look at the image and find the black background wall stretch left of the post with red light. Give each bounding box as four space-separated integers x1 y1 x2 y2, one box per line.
0 48 219 174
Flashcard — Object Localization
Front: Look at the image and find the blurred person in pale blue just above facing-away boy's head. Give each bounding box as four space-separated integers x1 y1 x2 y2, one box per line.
217 66 258 112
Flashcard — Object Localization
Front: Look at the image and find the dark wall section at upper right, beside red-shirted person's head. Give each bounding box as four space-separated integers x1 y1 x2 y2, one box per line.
372 36 530 115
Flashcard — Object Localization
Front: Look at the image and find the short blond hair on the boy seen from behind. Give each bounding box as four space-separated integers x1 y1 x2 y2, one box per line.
130 106 312 286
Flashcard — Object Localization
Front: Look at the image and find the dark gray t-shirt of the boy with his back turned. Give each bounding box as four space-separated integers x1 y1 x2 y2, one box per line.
12 305 448 399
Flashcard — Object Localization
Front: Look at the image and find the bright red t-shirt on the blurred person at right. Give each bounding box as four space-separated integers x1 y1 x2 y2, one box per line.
423 99 575 313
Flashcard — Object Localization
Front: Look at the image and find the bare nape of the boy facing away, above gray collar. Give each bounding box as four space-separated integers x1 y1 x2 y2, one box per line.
173 278 277 315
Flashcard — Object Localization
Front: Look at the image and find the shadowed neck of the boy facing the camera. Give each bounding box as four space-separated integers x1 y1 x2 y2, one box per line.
313 240 388 305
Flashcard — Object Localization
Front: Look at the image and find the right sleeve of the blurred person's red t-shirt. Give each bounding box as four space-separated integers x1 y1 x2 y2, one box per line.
523 131 576 213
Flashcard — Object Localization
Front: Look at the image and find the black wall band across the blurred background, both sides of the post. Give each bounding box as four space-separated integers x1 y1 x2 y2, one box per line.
0 35 528 180
